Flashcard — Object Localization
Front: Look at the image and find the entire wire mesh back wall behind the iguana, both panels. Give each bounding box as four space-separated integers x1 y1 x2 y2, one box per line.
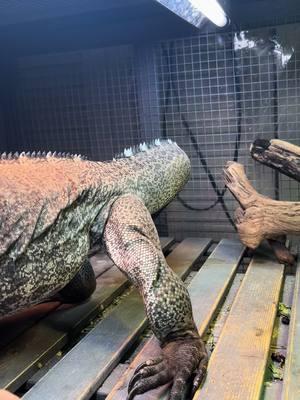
10 24 300 239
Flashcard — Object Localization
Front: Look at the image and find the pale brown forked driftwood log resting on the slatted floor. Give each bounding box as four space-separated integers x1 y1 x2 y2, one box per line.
224 161 300 264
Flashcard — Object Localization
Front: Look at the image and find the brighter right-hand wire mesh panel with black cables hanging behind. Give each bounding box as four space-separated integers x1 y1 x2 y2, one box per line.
151 26 300 239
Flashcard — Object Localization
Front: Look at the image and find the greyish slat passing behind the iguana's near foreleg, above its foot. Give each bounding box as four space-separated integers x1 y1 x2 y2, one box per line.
23 239 210 400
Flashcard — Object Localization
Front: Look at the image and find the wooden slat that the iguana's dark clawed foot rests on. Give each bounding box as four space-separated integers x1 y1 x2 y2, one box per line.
107 239 245 400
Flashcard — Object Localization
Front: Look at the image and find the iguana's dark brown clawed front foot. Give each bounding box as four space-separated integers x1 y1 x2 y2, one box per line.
127 338 208 400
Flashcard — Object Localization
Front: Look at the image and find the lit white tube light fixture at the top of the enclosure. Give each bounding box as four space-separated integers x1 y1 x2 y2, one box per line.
156 0 229 28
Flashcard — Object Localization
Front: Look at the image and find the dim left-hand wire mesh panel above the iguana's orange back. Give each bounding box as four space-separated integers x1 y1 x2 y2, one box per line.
13 46 140 160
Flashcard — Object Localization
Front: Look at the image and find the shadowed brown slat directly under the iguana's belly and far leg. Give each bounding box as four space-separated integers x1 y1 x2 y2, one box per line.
0 234 176 391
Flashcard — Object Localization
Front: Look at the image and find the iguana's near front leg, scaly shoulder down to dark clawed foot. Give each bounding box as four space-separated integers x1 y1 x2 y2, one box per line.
104 195 207 400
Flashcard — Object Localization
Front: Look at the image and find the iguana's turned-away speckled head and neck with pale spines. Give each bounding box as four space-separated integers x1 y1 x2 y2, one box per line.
96 141 190 213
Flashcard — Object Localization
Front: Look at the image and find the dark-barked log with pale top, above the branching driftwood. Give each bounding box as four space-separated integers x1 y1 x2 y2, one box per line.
250 139 300 182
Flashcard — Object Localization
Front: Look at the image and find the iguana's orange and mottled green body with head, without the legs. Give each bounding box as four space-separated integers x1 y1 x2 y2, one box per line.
0 142 190 316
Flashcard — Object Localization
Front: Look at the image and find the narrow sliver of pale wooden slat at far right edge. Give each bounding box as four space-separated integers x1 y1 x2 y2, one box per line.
282 251 300 400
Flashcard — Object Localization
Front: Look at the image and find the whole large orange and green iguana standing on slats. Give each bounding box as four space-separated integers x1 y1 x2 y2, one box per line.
0 140 207 400
